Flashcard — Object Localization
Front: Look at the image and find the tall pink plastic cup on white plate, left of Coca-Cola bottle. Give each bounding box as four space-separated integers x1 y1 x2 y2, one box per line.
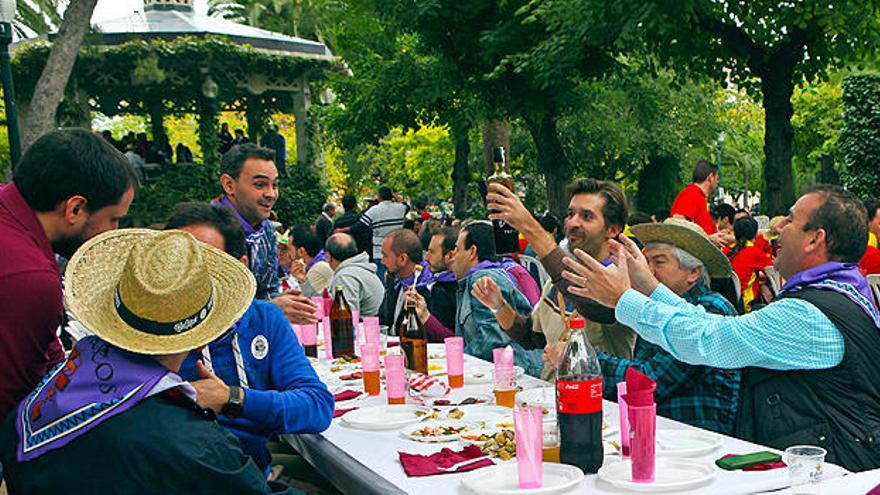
513 407 544 489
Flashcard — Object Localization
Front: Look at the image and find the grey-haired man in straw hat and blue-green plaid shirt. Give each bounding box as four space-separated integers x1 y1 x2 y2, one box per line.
552 218 740 434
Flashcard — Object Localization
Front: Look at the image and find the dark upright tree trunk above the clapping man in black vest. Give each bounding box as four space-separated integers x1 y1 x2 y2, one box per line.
761 57 794 216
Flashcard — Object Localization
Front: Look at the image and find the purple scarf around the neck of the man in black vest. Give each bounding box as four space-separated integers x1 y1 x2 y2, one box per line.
782 261 880 327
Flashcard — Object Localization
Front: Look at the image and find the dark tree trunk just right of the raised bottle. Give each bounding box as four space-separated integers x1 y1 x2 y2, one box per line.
523 112 572 218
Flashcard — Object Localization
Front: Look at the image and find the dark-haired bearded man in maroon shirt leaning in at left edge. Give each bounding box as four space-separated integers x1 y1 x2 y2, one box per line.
0 129 137 418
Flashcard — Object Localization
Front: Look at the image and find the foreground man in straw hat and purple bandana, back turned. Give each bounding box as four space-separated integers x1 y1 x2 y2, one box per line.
0 229 292 495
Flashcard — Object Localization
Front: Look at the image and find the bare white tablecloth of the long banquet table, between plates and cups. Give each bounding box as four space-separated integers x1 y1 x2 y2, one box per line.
285 344 847 495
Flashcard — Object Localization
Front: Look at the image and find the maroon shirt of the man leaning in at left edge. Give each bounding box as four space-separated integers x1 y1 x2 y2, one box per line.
0 183 64 417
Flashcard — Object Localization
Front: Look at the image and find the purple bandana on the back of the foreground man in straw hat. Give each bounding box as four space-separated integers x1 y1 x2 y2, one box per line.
15 336 171 462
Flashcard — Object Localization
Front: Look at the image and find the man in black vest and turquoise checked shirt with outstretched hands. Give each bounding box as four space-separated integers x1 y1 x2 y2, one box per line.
564 186 880 471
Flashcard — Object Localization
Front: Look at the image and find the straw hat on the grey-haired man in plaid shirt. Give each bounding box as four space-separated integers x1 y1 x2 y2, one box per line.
632 218 733 278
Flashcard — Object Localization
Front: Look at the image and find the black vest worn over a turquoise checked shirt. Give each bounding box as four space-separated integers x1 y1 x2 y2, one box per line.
736 289 880 471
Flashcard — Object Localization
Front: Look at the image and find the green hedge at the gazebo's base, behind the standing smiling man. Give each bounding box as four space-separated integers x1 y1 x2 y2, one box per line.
128 164 327 227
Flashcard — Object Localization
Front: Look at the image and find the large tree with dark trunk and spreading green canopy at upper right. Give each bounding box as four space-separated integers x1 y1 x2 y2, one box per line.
536 0 880 214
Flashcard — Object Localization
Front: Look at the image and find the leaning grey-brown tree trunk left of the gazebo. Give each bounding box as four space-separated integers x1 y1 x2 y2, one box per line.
21 0 98 150
